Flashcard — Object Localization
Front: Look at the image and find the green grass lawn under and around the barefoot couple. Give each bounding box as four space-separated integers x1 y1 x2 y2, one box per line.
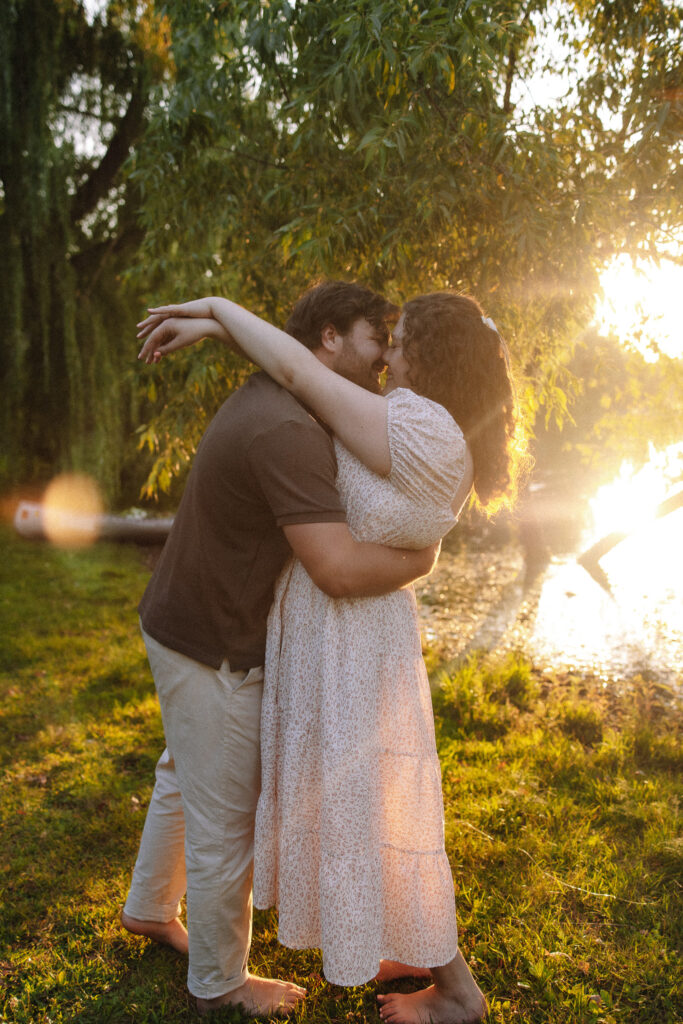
0 529 683 1024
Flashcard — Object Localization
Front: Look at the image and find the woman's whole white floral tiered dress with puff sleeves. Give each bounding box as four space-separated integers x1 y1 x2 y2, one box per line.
254 388 466 985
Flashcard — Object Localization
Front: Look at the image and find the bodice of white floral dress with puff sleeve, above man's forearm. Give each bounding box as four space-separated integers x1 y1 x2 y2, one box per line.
335 388 467 548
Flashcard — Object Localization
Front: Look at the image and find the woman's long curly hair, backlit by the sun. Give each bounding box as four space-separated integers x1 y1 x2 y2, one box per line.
402 292 523 515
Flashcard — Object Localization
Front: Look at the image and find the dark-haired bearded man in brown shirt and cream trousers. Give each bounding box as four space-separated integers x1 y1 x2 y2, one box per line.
122 282 435 1015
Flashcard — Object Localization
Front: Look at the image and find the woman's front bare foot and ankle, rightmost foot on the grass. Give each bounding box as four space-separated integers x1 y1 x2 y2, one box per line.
377 950 488 1024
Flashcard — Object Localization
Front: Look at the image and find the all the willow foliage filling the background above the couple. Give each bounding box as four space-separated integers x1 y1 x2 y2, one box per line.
0 0 683 503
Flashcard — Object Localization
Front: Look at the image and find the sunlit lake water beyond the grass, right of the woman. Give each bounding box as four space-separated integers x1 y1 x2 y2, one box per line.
417 509 683 686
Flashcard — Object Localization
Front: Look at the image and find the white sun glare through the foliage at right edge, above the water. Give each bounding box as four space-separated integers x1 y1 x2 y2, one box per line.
595 256 683 361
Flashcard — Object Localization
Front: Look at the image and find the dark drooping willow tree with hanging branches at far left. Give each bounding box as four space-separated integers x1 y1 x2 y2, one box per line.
0 0 167 493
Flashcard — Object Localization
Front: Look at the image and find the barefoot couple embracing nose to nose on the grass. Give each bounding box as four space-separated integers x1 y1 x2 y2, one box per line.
122 282 515 1024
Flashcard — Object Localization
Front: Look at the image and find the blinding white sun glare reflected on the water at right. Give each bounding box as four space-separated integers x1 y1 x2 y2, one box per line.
530 443 683 681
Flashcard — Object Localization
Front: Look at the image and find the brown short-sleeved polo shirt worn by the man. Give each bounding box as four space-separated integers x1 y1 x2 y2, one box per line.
139 373 346 670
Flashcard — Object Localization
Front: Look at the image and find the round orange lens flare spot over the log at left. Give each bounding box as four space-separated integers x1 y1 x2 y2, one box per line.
42 473 102 548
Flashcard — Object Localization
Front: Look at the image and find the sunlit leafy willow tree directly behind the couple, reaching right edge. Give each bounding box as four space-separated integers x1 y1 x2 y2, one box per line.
133 0 683 495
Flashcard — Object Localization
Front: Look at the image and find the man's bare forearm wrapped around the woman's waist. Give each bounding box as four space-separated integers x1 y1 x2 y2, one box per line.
283 522 440 597
